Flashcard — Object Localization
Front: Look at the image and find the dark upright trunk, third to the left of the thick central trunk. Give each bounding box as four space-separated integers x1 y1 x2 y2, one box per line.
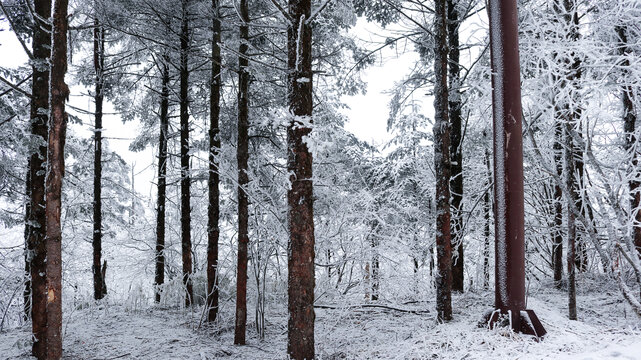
180 0 194 306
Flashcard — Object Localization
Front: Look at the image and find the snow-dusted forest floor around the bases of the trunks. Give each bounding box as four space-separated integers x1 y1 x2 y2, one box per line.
0 286 641 360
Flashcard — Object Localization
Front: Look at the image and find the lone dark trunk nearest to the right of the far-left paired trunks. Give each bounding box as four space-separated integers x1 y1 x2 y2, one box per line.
92 14 107 300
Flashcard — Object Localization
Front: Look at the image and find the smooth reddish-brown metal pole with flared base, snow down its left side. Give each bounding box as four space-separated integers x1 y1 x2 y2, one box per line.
489 0 545 336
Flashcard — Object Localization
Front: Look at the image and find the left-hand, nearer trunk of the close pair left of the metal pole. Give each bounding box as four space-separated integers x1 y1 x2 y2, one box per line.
434 0 452 321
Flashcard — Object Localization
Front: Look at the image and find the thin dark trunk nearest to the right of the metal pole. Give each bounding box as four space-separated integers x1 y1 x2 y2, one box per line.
552 119 563 289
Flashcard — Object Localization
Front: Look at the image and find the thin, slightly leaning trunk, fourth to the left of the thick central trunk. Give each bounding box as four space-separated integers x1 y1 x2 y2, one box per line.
154 57 169 303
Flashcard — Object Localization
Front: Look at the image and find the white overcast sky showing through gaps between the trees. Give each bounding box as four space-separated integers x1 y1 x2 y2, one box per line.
0 19 418 205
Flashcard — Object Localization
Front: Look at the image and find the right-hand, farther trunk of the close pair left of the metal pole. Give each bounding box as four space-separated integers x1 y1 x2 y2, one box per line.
447 0 465 292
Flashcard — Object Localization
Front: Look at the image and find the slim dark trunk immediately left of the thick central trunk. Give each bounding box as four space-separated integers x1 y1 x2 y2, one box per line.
234 0 249 345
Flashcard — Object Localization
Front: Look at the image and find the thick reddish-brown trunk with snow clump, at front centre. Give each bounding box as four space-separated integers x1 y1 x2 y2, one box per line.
287 0 315 360
